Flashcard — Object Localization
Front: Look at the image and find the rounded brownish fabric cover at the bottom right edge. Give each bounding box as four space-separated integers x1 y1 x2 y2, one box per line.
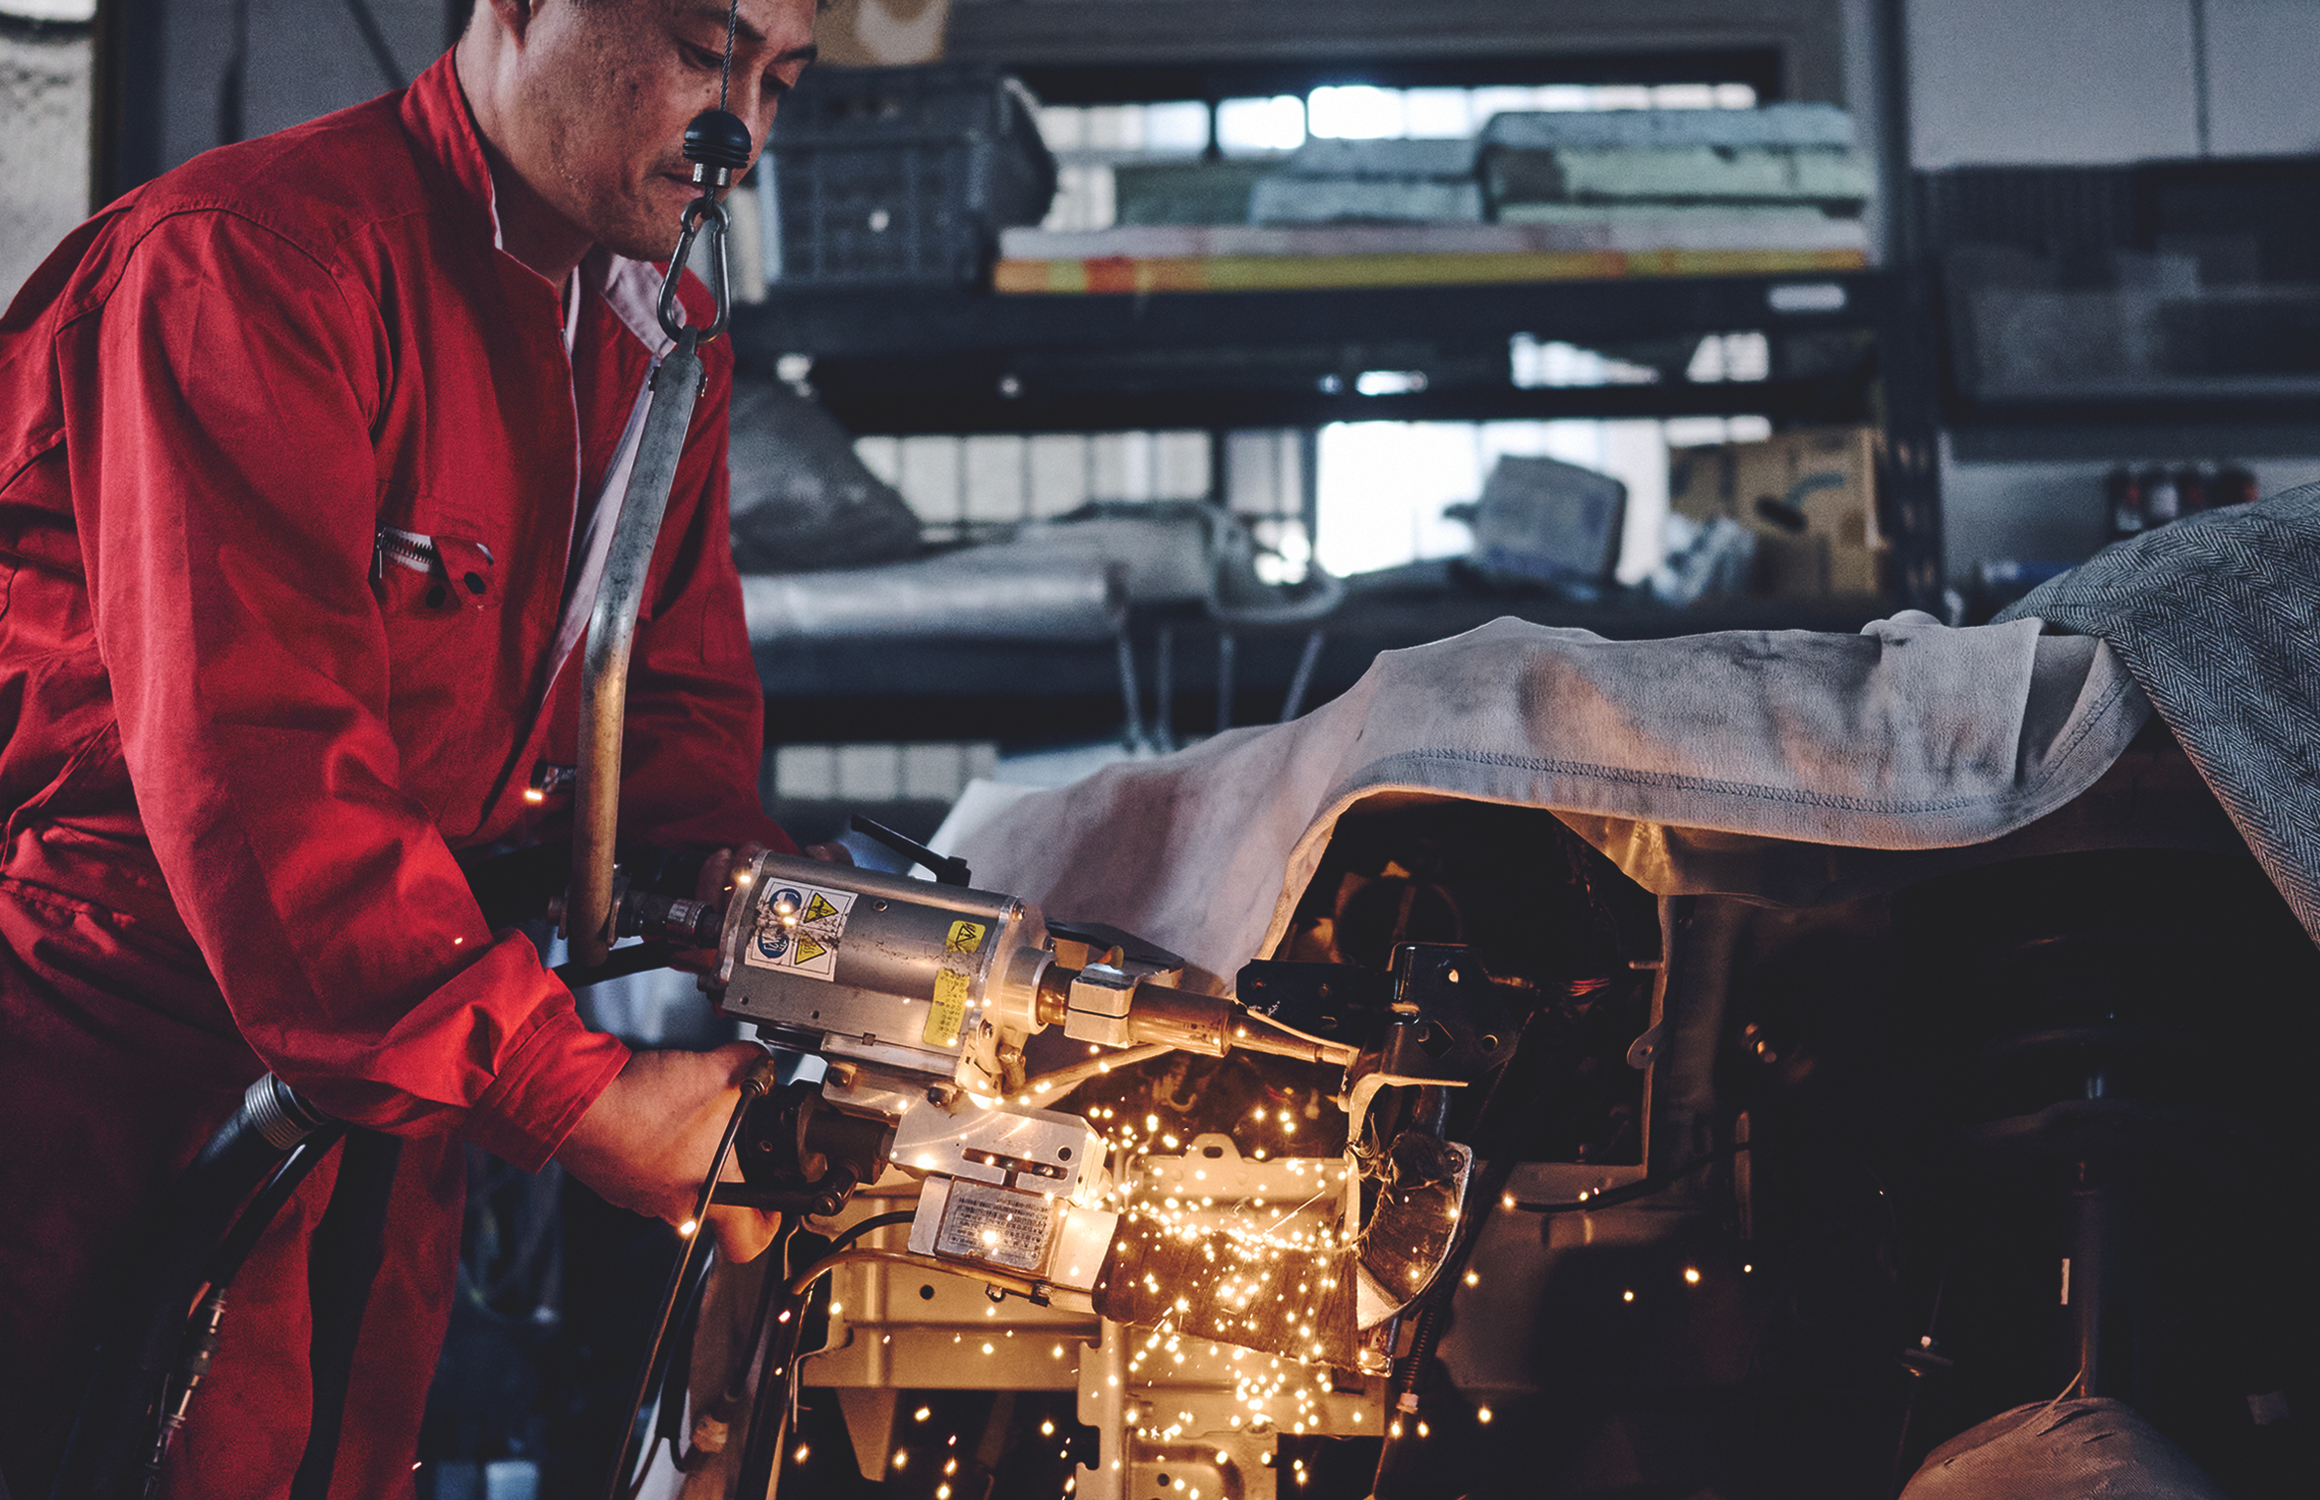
1900 1398 2225 1500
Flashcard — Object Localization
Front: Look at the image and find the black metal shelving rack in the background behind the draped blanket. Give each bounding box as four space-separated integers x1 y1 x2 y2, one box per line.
733 55 1942 744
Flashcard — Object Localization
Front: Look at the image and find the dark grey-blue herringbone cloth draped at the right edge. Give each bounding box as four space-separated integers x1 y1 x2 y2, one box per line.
1998 485 2320 941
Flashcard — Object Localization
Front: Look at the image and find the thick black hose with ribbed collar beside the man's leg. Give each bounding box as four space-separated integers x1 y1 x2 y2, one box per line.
49 1076 327 1500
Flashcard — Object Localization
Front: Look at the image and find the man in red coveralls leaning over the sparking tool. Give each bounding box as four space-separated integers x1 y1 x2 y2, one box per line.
0 0 814 1500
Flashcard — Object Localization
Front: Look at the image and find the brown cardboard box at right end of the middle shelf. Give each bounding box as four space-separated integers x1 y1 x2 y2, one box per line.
1668 427 1891 598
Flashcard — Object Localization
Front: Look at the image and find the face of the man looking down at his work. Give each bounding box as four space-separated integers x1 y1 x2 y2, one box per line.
503 0 814 260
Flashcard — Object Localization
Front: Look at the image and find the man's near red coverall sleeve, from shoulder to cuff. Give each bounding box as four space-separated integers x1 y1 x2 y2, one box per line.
58 213 626 1168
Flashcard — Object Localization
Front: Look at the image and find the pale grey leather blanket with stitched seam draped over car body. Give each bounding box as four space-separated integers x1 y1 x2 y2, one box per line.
944 612 2162 988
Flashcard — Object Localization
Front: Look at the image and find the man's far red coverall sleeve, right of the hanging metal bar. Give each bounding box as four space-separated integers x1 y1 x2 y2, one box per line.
619 345 796 853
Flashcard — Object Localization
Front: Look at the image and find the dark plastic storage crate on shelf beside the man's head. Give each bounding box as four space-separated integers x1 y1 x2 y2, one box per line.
759 65 1056 287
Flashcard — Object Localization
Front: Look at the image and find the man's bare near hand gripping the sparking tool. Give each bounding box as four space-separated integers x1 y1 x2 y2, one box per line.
557 1041 782 1264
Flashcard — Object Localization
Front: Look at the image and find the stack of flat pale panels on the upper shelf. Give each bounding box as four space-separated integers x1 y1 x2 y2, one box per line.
995 104 1875 294
